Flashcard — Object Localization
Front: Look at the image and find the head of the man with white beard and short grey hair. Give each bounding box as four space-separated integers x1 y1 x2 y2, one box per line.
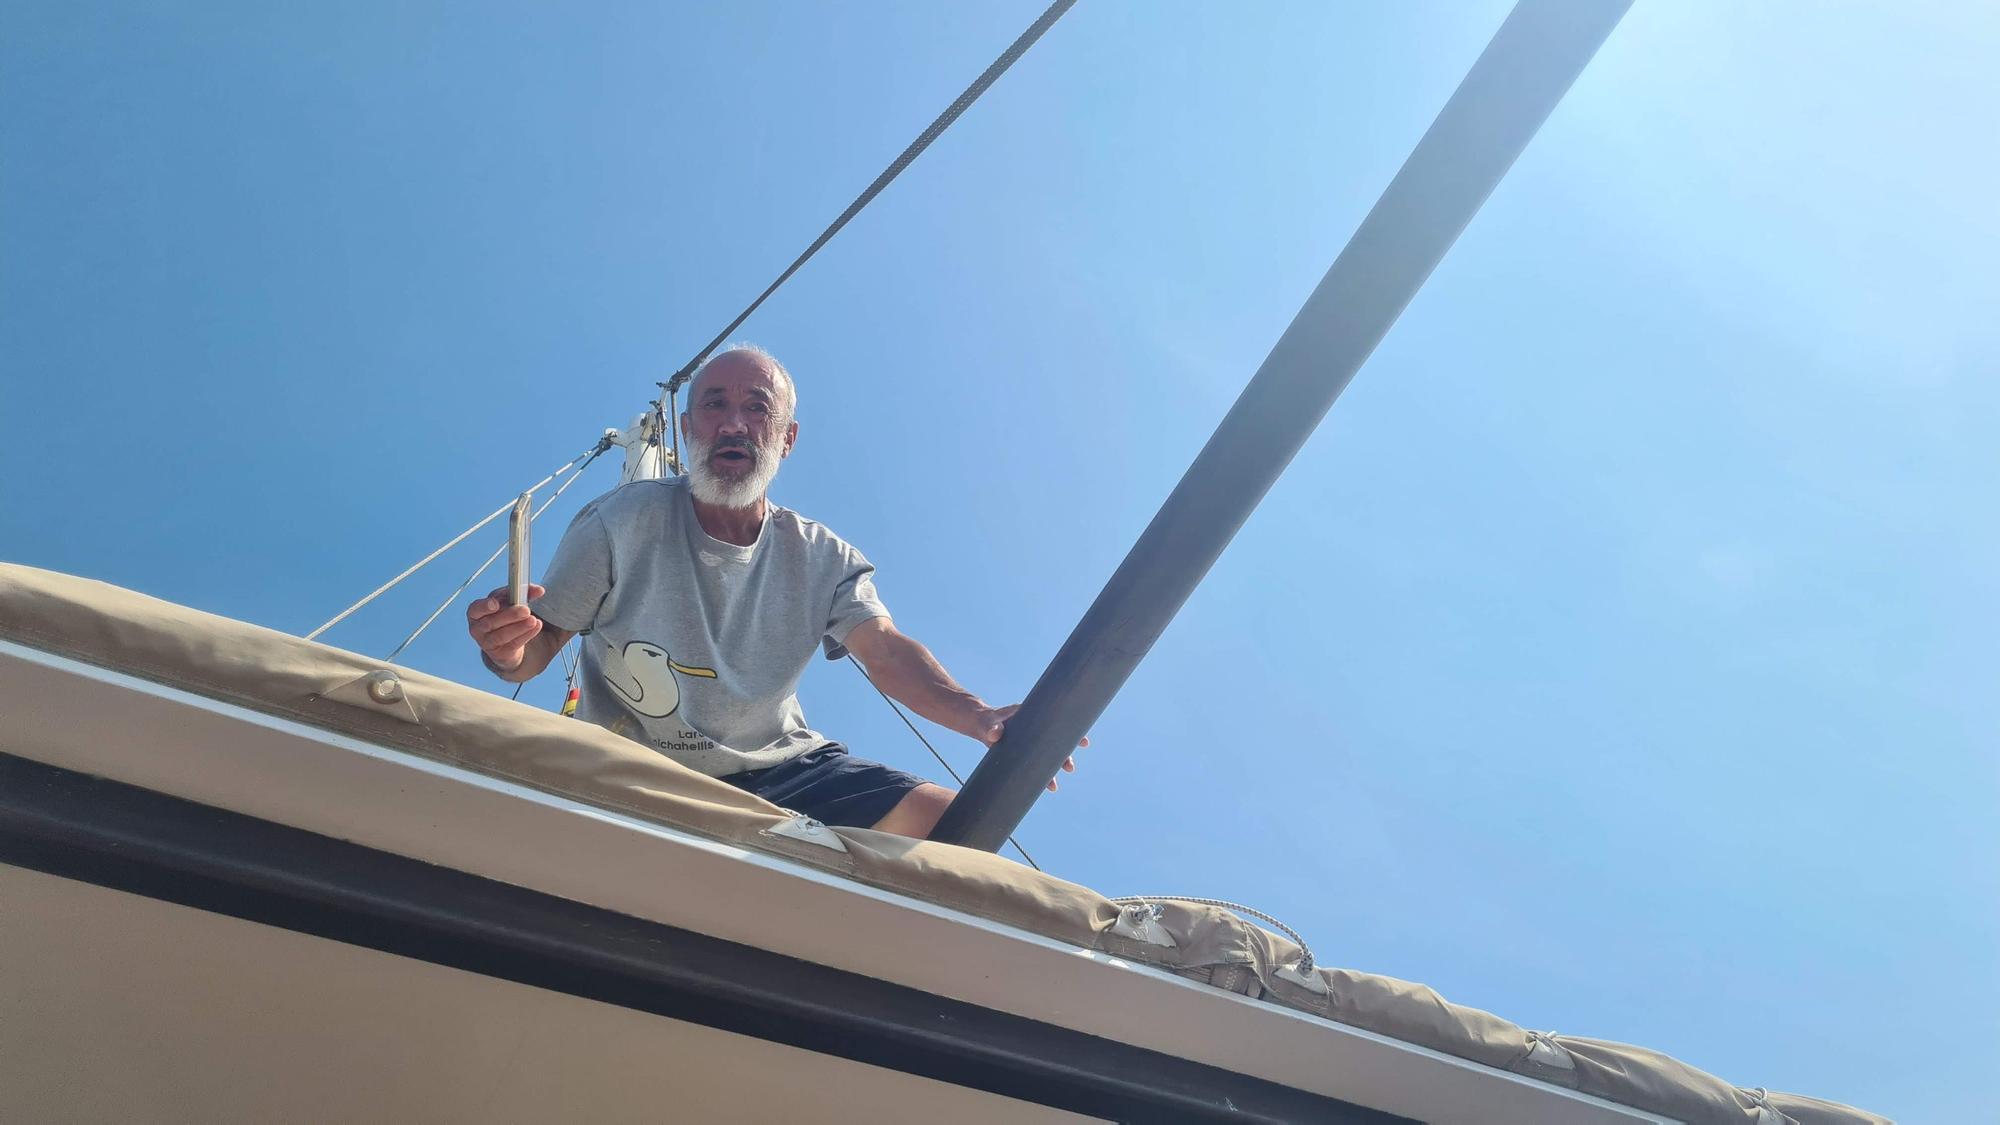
680 352 798 508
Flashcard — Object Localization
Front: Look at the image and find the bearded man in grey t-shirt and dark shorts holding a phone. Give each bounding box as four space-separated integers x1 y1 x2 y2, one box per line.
466 346 1074 839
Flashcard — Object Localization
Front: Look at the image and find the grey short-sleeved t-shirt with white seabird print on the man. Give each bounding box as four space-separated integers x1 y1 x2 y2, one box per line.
534 476 888 777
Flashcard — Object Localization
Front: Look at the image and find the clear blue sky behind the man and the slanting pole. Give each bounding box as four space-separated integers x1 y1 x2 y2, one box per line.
0 0 2000 1121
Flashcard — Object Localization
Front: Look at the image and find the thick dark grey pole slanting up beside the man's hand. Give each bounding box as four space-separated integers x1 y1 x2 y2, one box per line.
932 0 1630 851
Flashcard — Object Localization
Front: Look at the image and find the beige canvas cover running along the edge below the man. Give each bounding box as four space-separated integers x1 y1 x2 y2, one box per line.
0 565 1886 1125
